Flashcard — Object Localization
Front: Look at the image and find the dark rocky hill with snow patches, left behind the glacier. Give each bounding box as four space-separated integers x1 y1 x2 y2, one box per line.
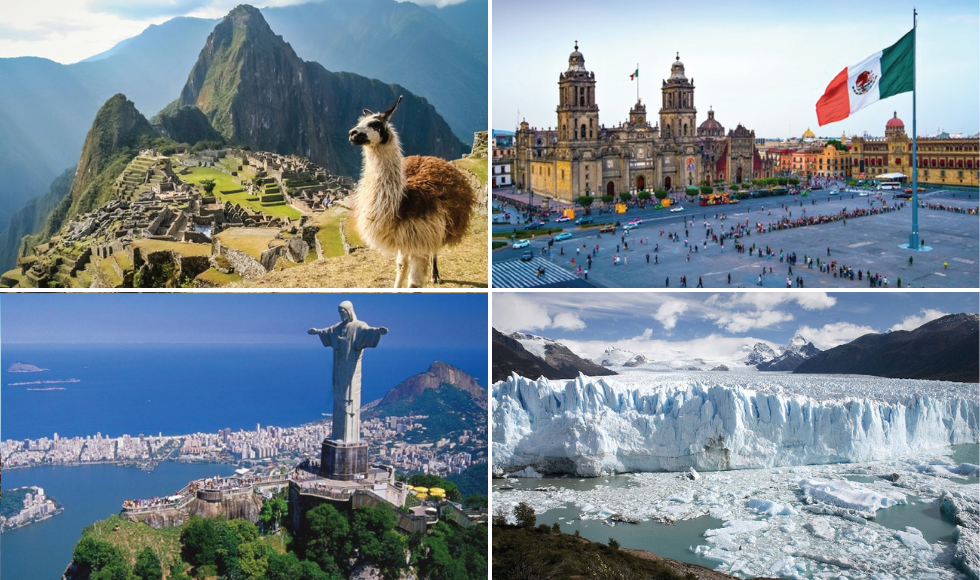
491 328 617 382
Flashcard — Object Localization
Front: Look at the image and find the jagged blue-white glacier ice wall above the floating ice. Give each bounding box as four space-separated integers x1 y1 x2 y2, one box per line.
492 373 980 476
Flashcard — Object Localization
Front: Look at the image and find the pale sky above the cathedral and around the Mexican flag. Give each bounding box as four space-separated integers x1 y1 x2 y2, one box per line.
492 0 980 137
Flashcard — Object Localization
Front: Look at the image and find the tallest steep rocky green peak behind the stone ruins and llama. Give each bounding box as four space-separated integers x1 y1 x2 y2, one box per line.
179 5 465 176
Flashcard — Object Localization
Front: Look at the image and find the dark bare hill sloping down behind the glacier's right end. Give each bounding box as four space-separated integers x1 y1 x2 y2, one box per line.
794 314 980 383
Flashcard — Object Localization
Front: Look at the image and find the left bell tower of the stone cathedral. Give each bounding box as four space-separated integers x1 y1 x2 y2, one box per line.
557 40 599 143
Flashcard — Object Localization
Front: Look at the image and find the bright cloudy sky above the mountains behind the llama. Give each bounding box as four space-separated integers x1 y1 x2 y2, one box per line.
0 0 463 64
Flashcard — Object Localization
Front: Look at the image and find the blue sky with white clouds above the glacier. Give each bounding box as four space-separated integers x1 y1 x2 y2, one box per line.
493 292 980 358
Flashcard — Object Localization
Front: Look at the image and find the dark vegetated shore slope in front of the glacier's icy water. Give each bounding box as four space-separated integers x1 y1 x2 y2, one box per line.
493 503 694 580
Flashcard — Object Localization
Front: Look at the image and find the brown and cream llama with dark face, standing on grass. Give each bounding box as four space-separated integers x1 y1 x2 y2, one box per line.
350 97 476 288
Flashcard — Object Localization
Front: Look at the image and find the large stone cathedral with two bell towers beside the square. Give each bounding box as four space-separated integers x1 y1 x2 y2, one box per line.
514 42 763 202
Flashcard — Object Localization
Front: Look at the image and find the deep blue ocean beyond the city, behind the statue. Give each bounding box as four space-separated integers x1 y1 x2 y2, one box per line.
0 337 487 439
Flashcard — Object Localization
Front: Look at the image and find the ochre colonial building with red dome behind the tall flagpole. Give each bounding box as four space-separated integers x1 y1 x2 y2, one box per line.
850 112 980 187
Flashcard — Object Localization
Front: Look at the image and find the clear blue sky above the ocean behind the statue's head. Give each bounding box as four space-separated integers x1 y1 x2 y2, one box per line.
0 292 487 348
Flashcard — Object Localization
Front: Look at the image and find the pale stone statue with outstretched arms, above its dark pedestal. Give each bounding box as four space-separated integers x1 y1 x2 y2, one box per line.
309 300 388 443
